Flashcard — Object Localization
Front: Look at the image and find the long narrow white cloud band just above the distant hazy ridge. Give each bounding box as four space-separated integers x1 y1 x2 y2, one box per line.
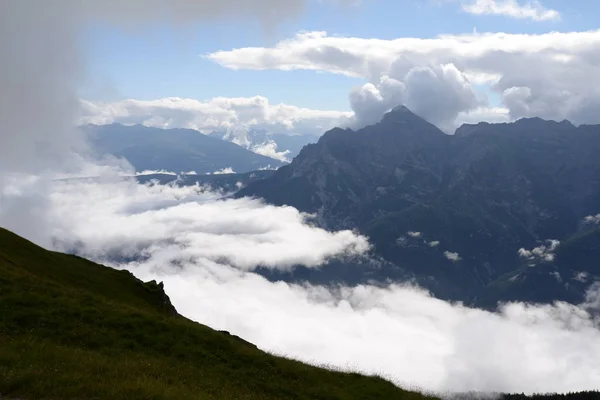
78 96 352 138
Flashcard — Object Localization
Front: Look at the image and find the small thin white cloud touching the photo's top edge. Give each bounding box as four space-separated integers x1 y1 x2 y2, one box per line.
462 0 560 21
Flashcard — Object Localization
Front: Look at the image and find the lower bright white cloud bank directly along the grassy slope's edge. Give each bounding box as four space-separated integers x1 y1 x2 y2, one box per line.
161 266 600 393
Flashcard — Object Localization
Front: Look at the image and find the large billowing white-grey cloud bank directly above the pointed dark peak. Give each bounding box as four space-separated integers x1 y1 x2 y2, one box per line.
207 31 600 130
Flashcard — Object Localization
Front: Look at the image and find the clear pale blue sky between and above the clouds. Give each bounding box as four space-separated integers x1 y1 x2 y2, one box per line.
81 0 600 110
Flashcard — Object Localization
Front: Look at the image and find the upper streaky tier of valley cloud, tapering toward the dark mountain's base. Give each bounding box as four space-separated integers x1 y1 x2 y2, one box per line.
38 180 369 270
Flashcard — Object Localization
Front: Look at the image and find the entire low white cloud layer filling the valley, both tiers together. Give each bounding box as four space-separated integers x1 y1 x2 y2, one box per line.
0 176 600 392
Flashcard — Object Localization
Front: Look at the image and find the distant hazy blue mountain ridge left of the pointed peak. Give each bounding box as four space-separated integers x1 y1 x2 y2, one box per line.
82 124 284 174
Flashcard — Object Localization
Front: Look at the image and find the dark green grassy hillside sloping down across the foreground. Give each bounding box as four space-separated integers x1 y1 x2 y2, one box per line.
0 229 434 400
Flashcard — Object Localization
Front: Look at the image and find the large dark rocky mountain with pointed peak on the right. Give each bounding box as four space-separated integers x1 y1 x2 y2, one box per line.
238 107 600 305
